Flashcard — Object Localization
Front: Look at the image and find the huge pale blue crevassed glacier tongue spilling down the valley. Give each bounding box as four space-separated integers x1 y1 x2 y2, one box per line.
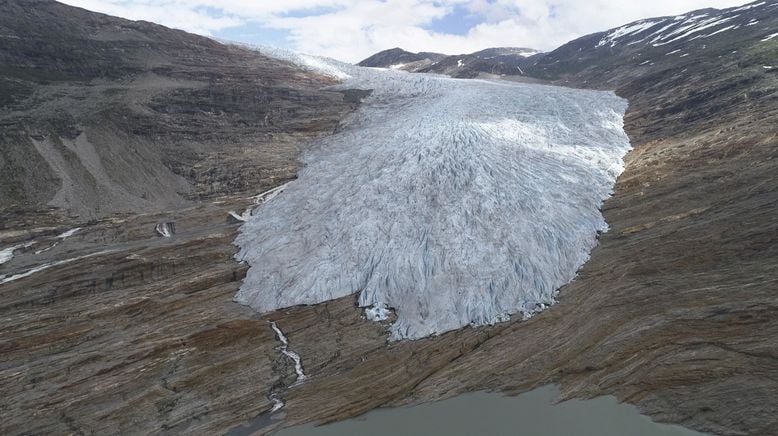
235 50 630 339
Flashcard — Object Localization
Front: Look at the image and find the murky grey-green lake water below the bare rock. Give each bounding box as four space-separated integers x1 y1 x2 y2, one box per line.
266 386 702 436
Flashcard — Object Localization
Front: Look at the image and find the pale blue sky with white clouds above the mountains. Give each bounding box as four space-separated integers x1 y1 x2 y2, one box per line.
60 0 748 62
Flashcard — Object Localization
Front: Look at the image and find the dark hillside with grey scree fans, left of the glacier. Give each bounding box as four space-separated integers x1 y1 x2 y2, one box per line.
0 0 353 218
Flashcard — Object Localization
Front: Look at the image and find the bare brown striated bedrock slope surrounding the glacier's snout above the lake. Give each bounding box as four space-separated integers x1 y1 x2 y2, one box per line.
0 1 778 435
